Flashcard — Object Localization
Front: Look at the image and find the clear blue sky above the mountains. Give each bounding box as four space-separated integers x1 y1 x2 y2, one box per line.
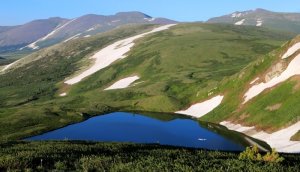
0 0 300 26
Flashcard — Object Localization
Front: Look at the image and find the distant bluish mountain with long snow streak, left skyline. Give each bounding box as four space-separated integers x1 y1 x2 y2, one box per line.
0 12 176 53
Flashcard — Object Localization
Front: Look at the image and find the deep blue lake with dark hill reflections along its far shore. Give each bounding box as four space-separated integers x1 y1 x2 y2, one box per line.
25 112 270 151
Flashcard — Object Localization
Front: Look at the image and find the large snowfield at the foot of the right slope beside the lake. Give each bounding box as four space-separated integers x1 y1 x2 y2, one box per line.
220 121 300 153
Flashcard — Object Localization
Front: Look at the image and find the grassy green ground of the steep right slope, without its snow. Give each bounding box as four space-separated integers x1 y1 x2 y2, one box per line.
202 37 300 131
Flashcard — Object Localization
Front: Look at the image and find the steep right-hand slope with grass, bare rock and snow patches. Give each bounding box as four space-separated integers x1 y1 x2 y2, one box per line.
197 36 300 152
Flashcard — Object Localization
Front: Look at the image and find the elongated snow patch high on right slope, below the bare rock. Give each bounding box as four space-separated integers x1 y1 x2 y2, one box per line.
243 54 300 104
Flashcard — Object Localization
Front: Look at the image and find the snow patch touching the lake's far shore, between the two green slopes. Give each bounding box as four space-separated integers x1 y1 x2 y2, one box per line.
175 95 224 118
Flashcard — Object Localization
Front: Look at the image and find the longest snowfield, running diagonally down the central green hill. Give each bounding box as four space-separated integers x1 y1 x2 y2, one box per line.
65 24 176 85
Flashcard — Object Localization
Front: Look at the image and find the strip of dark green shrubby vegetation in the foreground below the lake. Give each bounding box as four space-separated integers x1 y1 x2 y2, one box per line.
0 141 300 172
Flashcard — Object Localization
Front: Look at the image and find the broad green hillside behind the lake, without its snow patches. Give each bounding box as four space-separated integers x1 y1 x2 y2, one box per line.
0 24 293 140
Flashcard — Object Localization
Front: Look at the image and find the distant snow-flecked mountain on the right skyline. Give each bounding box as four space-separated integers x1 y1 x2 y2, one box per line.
207 9 300 33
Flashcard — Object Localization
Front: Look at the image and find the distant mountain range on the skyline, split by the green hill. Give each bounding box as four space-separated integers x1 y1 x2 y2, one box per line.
0 9 300 60
